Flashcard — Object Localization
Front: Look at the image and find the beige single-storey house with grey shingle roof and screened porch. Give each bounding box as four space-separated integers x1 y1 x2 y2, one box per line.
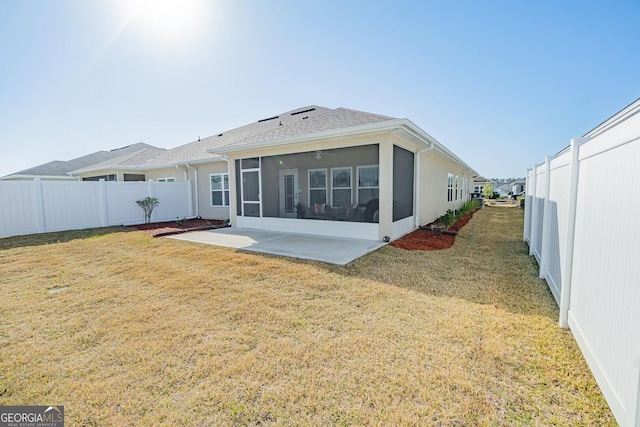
3 105 478 240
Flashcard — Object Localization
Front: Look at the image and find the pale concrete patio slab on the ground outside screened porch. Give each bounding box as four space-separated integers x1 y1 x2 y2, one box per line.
167 228 386 265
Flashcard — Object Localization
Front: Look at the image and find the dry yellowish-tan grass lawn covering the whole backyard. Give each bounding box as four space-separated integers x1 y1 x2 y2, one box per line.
0 208 615 425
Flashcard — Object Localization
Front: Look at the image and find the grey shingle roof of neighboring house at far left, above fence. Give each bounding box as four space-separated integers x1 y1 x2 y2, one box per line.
4 142 165 179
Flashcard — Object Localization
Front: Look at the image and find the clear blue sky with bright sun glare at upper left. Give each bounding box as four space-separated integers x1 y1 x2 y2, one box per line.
0 0 640 178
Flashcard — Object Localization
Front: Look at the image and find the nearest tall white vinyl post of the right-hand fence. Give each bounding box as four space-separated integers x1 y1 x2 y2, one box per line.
559 138 591 328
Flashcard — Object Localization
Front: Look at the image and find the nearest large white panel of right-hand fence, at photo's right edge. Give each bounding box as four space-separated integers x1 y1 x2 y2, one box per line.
569 135 640 425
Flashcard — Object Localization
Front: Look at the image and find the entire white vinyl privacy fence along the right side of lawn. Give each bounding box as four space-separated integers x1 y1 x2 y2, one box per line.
524 101 640 427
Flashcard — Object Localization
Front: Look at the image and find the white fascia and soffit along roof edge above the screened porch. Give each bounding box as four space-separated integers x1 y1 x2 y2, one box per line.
207 119 432 154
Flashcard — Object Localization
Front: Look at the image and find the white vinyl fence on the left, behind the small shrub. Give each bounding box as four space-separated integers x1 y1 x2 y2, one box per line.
0 179 193 238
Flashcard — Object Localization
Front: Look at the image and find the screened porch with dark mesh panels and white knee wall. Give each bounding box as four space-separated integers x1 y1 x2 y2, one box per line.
228 144 414 240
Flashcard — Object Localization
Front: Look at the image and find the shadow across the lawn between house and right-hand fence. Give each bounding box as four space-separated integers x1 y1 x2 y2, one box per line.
322 208 558 320
